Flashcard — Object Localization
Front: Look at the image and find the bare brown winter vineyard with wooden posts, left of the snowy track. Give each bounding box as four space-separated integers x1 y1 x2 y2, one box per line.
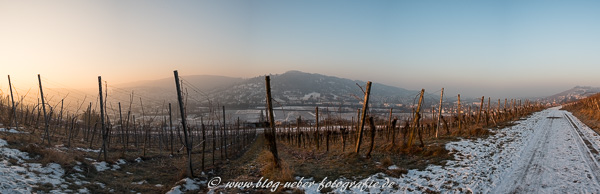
0 71 548 193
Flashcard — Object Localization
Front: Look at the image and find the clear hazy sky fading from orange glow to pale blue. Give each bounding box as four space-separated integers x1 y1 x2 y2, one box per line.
0 0 600 98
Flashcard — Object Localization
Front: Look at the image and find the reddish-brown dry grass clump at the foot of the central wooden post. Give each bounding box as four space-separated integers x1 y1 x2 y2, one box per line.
258 149 294 183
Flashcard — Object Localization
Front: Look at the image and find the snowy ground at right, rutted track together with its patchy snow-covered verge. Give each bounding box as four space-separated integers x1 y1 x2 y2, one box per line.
307 107 600 193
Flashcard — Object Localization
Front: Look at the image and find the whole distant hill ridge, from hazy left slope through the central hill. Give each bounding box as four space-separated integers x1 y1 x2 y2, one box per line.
118 71 418 106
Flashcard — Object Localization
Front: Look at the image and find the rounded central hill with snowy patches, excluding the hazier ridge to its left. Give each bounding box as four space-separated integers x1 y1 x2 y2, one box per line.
216 71 417 105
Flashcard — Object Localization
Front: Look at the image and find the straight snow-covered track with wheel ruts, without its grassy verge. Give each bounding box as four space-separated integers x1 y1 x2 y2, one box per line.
495 108 600 193
